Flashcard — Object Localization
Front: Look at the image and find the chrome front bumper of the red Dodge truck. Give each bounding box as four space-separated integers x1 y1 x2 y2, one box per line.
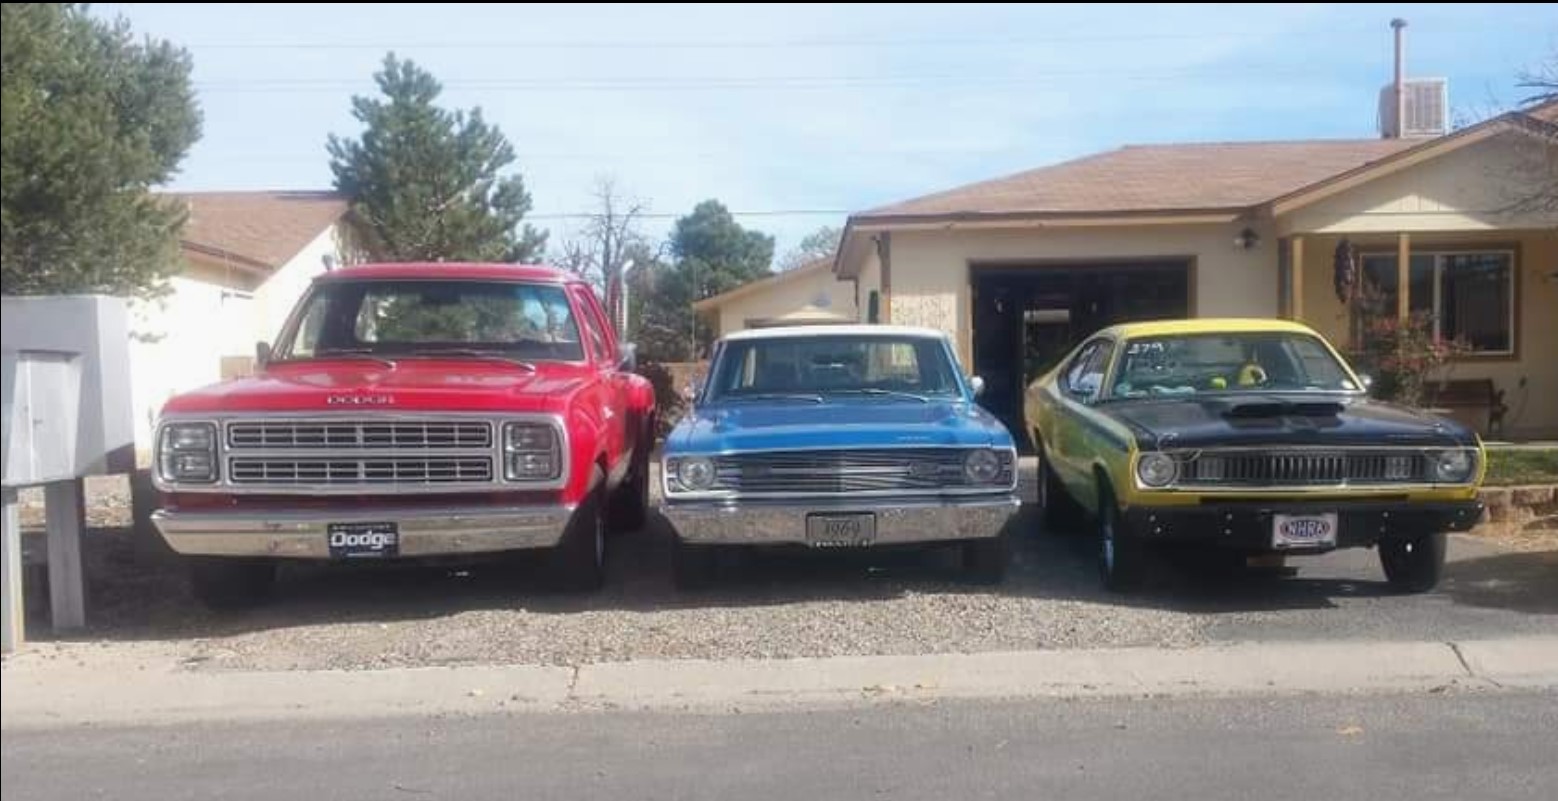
151 506 573 559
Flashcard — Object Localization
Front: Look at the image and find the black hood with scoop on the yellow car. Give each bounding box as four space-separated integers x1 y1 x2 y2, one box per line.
1098 394 1477 449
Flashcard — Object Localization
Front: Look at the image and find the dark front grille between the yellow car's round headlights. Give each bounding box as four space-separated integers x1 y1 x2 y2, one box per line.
1179 450 1429 486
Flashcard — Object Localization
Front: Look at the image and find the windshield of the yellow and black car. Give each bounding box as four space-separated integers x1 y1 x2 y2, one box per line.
1108 332 1359 399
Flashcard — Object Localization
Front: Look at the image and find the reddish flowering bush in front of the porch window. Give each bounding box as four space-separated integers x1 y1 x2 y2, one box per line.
1355 312 1471 407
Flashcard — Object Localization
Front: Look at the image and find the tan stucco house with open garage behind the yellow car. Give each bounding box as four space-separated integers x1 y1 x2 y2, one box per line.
720 103 1558 438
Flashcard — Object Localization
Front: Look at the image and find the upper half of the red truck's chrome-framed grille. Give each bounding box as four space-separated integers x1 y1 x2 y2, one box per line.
227 419 492 450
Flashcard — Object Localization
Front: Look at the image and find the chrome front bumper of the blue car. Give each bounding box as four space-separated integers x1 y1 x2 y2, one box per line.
661 496 1022 545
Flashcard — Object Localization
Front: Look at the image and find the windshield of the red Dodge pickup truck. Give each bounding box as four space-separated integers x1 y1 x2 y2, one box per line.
277 281 584 362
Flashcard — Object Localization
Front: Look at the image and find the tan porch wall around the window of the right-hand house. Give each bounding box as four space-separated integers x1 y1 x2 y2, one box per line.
1304 229 1558 438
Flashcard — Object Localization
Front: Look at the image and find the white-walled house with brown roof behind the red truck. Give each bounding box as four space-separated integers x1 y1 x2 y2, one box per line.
129 192 357 452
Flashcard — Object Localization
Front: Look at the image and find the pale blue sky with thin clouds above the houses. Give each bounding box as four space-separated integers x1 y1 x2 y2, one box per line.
103 3 1558 251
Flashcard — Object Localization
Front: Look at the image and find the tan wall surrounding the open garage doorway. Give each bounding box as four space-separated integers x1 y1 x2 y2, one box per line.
891 223 1278 365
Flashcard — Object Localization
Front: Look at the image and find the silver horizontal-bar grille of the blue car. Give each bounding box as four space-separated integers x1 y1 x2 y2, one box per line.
712 447 1014 494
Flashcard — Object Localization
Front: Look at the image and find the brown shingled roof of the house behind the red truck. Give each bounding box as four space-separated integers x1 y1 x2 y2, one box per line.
168 192 347 270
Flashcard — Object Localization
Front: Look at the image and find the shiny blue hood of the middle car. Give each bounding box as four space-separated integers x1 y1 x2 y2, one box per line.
665 401 1011 453
